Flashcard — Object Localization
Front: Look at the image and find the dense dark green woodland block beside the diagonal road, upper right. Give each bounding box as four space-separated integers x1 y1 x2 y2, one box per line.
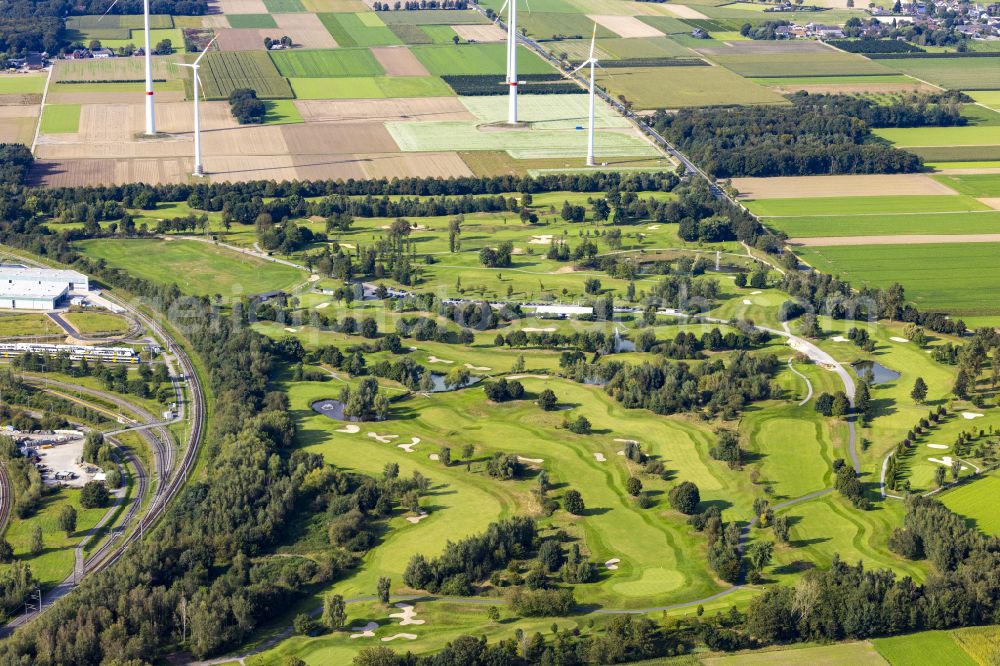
653 92 965 178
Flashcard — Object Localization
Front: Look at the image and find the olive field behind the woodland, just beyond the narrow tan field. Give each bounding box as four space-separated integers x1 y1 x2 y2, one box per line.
709 52 892 78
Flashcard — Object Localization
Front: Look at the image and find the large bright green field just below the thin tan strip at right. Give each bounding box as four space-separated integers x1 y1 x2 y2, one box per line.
796 243 1000 315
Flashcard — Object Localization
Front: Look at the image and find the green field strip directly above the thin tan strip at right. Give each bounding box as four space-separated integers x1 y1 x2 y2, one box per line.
764 211 1000 238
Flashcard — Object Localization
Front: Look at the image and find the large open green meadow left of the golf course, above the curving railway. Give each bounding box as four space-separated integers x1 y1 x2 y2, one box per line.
80 239 306 300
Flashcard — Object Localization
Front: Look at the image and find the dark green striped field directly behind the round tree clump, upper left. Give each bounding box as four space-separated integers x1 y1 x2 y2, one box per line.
201 51 292 99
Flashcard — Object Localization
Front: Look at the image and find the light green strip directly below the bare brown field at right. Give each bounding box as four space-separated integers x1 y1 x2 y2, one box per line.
743 194 990 217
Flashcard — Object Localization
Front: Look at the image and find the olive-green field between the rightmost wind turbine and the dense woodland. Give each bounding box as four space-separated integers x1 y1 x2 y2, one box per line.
597 67 788 109
